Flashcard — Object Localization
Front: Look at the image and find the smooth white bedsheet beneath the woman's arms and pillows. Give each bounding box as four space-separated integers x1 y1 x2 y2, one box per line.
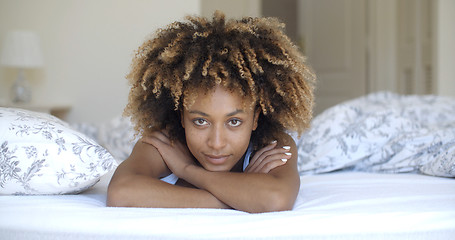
0 172 455 239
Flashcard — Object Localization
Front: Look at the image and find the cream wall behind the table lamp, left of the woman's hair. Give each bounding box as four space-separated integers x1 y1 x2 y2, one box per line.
0 0 200 123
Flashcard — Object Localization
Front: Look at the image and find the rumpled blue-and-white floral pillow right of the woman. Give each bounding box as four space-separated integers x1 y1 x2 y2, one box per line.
296 92 455 177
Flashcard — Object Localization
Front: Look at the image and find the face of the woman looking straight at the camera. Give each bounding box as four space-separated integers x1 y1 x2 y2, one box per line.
182 86 259 171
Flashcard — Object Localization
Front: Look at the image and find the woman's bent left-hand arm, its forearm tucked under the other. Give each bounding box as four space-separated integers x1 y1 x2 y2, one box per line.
107 141 229 208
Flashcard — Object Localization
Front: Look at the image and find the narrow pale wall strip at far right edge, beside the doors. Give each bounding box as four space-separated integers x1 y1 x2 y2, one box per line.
433 0 455 96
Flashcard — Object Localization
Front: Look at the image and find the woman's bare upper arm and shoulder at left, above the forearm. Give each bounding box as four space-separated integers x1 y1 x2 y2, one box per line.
114 139 170 178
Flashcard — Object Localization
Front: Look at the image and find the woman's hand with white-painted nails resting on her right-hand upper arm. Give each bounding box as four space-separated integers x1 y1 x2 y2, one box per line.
245 141 291 173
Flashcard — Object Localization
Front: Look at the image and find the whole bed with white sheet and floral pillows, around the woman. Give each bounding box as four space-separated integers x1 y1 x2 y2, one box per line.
0 92 455 239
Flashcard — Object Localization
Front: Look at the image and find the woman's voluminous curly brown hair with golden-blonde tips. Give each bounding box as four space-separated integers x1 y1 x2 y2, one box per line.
124 11 316 148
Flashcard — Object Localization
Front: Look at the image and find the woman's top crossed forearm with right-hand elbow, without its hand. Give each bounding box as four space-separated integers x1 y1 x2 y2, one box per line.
187 134 300 212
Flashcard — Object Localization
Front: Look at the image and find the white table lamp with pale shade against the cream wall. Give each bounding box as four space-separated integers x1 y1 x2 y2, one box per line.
0 31 44 103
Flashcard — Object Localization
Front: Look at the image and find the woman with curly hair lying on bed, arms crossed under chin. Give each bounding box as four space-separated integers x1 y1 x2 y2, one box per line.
107 12 315 212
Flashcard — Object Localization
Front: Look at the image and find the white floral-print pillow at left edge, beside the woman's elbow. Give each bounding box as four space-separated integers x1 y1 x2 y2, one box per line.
0 108 117 195
